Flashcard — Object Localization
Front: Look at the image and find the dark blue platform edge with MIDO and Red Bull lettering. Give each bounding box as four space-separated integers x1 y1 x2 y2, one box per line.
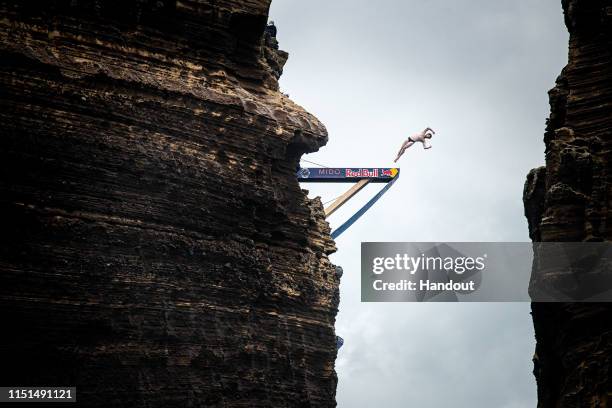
296 167 399 183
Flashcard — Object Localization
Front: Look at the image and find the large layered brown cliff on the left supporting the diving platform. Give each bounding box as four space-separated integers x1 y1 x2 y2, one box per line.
0 0 339 407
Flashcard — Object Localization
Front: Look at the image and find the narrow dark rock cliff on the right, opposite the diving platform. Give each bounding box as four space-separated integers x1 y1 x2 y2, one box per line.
524 0 612 408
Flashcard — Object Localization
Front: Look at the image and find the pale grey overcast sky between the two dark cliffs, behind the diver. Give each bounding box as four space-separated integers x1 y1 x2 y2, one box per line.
270 0 568 408
